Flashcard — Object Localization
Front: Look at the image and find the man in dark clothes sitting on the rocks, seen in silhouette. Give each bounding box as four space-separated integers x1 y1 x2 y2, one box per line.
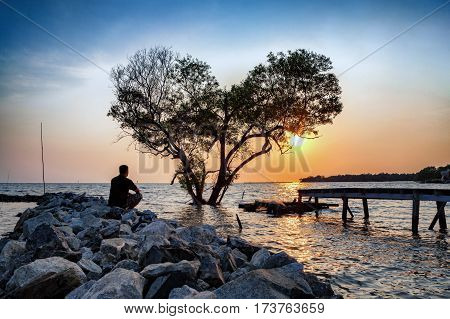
108 165 142 209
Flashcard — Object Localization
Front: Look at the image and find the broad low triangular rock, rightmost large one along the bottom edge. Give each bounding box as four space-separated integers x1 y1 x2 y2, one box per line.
214 269 314 299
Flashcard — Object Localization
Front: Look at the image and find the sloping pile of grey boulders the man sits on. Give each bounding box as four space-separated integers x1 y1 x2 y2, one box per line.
0 193 338 299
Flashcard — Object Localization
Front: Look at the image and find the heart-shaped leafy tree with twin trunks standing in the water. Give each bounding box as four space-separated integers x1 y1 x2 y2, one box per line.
108 47 342 205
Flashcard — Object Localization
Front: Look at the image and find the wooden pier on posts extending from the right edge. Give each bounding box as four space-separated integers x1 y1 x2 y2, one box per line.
298 188 450 234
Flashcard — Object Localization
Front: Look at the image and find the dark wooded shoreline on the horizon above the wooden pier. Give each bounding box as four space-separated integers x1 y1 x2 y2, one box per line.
300 164 450 183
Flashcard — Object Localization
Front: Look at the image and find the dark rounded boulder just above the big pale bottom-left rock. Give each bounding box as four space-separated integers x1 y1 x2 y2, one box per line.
26 224 72 258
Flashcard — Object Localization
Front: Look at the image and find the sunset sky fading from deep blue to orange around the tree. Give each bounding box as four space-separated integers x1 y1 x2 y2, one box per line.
0 0 450 182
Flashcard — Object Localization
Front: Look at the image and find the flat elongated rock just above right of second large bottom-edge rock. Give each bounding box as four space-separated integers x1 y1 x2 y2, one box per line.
141 260 200 280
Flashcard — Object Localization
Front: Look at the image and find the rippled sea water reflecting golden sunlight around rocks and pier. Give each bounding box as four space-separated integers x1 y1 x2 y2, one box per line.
0 182 450 298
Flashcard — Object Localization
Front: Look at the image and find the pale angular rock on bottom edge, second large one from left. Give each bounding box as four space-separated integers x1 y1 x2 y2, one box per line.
82 268 146 299
